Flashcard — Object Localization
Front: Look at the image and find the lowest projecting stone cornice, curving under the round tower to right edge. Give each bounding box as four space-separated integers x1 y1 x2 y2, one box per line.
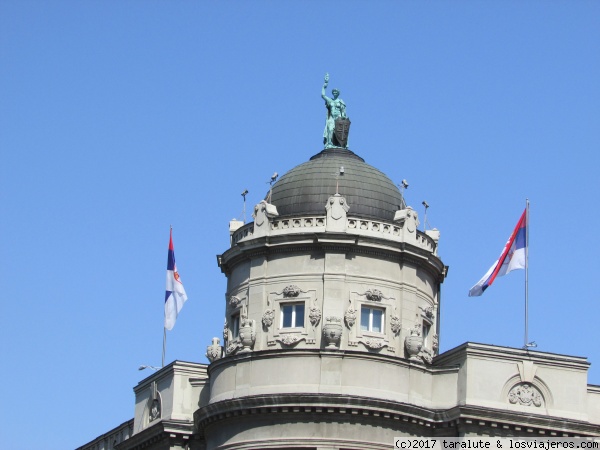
194 394 600 437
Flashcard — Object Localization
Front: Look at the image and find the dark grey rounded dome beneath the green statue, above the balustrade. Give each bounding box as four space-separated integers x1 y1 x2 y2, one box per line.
271 148 404 222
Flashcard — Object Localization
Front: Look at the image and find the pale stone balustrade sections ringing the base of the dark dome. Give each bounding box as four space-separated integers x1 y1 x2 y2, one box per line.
231 216 437 252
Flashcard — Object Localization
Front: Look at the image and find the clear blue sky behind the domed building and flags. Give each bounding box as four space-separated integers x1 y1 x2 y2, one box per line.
0 0 600 449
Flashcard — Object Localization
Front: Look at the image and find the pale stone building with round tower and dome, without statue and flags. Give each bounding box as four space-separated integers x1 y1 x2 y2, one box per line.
81 148 600 450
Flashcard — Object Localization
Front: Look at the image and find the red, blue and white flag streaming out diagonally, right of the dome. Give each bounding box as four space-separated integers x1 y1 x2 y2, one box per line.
469 208 527 297
